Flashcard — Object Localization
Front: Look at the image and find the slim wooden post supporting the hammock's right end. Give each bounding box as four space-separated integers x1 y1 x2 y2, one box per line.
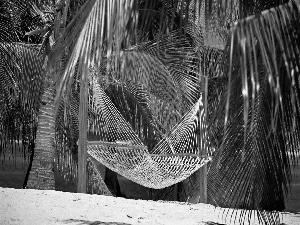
199 76 208 203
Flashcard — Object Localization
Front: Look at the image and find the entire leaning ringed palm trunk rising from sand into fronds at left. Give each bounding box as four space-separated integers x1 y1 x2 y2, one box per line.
26 9 63 190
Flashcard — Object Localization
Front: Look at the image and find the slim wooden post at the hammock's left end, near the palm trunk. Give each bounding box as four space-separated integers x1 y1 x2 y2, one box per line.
77 65 88 193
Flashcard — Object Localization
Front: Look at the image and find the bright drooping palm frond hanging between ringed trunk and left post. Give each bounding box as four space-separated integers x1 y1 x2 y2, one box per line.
53 0 139 184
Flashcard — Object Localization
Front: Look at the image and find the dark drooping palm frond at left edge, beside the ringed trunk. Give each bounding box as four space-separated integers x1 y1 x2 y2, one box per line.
0 43 43 169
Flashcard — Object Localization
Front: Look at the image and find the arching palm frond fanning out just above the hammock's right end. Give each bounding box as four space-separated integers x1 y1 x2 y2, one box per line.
124 30 199 109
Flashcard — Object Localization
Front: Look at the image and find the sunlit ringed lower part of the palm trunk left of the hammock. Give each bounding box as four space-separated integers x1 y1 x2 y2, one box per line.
26 88 55 190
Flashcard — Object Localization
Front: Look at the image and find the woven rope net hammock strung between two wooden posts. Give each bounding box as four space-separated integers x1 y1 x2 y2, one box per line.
88 83 211 189
